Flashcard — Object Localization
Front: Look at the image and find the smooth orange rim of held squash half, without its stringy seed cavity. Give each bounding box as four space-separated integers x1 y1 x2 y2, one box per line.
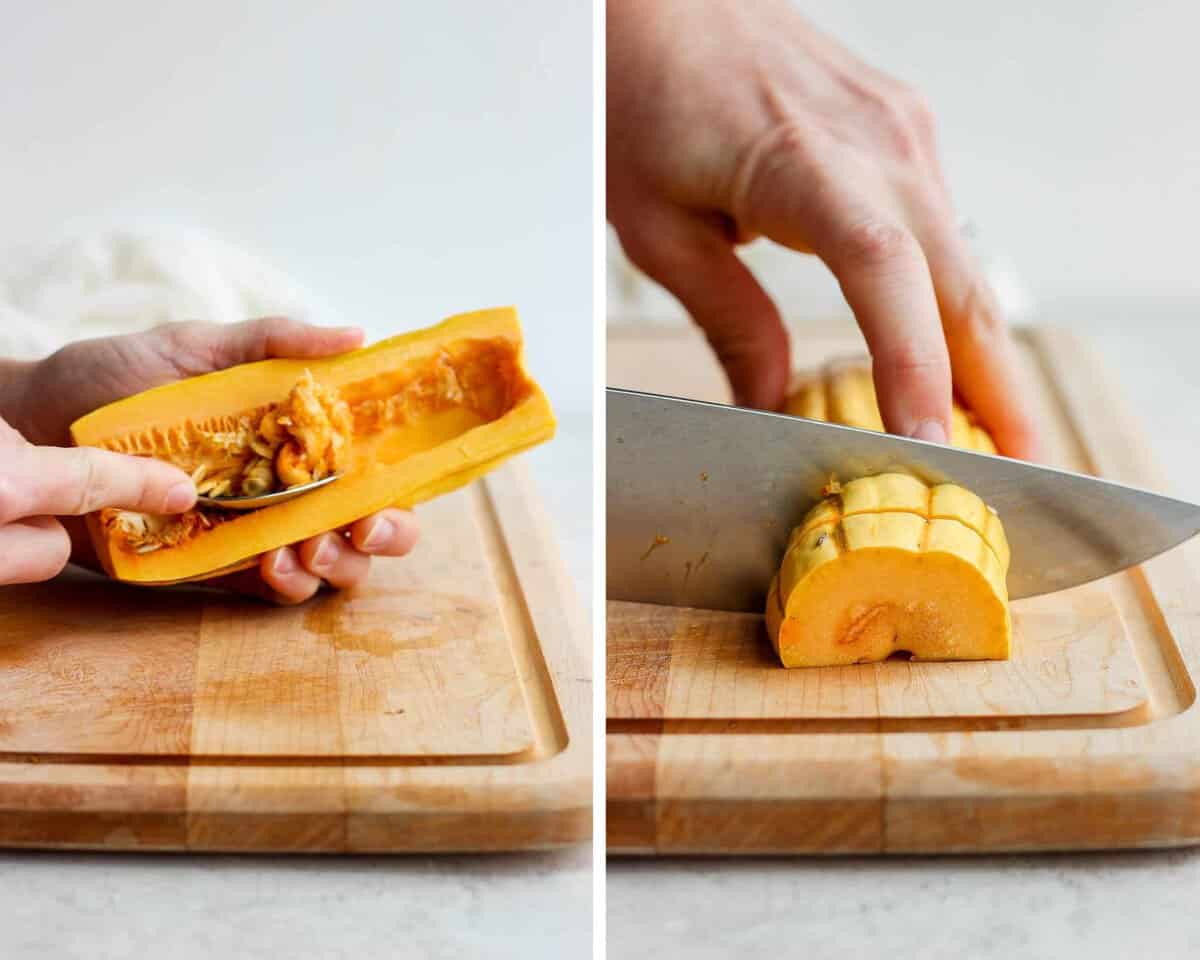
71 307 556 584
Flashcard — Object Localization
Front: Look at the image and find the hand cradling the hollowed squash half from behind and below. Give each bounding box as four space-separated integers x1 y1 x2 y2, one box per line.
0 318 418 604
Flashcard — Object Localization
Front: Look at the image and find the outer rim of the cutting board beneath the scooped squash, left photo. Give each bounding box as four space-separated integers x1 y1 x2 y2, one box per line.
0 461 592 853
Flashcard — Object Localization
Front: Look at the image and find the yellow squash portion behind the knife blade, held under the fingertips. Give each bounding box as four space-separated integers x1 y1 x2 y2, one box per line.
784 360 996 454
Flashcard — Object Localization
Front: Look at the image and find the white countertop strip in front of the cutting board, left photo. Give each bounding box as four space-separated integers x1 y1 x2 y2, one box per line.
0 848 592 960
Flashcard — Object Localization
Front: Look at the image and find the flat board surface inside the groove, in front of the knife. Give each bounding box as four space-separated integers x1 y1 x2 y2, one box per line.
607 586 1146 720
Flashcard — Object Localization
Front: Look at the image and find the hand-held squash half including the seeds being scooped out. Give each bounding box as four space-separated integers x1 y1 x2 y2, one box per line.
71 307 554 583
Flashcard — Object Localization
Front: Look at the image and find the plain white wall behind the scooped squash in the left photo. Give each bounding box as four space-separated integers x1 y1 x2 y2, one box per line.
0 0 592 420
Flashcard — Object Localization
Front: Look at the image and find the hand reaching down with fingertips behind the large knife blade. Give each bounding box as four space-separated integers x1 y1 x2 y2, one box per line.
607 0 1036 456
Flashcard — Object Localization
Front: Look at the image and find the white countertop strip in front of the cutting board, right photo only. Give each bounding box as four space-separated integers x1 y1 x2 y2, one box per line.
608 851 1200 960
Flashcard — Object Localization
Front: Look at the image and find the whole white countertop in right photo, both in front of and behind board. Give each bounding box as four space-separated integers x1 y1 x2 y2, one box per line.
607 300 1200 960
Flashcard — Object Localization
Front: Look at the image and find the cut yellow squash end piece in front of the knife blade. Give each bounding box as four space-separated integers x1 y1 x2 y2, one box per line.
766 474 1012 667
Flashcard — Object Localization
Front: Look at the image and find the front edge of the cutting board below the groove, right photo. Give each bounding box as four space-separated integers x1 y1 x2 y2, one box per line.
606 706 1200 854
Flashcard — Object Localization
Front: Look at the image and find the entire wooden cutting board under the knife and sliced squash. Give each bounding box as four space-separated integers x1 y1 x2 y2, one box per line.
606 328 1200 853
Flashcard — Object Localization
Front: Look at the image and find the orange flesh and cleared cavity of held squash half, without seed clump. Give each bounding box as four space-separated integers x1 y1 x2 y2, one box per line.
71 307 554 583
